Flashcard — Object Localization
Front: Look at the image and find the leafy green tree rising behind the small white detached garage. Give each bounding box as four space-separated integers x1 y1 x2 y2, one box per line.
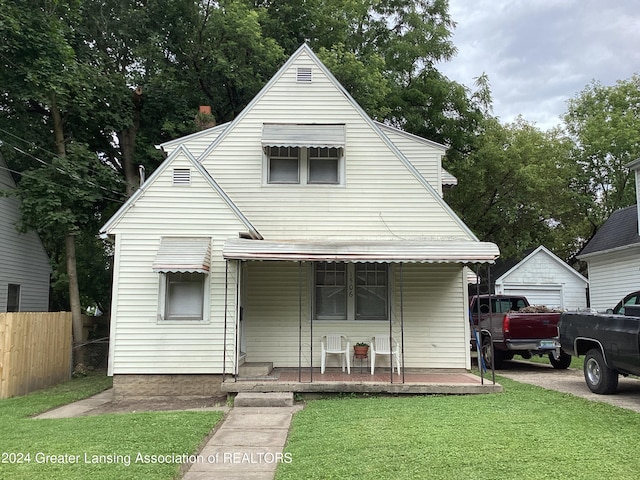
445 118 581 258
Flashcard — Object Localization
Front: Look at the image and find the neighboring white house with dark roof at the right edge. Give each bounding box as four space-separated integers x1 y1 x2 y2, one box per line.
577 159 640 312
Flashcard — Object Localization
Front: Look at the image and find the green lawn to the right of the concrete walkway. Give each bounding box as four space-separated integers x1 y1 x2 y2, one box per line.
276 377 640 480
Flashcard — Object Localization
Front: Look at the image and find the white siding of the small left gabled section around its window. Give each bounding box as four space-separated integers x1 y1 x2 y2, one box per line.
109 157 246 374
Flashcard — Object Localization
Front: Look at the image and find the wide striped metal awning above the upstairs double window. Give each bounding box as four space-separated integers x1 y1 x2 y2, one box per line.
262 123 345 148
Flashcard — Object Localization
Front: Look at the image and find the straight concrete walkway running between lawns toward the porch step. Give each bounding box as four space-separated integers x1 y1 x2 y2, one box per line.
182 406 302 480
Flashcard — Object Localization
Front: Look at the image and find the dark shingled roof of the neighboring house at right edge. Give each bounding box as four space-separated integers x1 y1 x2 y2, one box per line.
577 205 640 260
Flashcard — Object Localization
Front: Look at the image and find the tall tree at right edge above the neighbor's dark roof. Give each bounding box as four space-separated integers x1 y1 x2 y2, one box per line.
565 75 640 239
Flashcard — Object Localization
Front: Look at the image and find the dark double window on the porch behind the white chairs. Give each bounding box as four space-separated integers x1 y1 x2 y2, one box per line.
314 262 389 320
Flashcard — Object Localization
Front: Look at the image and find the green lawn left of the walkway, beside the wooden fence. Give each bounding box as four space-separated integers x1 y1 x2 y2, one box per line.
0 375 222 480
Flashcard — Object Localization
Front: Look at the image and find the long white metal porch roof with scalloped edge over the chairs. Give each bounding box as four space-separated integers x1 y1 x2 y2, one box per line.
222 238 500 263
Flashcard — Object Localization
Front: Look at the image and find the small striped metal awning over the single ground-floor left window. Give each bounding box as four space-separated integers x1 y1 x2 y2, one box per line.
153 237 211 273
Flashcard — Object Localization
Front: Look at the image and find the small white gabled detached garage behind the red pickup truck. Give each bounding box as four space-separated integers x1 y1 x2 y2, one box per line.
495 245 589 310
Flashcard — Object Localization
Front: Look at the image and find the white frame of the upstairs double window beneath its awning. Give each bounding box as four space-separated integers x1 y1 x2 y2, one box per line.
262 146 345 187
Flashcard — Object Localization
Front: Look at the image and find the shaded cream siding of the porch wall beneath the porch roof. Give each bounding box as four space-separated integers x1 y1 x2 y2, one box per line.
245 262 469 368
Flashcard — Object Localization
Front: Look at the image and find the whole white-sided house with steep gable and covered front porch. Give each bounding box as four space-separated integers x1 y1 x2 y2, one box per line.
102 45 499 397
